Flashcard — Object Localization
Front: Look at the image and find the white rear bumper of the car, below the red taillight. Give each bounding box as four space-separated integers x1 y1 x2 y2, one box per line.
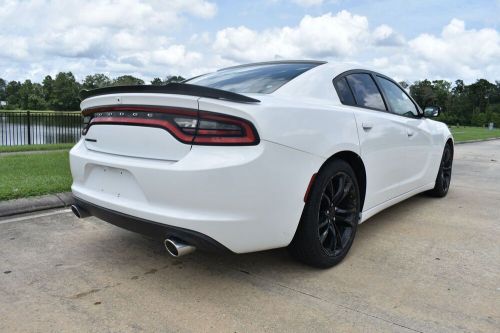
70 140 324 253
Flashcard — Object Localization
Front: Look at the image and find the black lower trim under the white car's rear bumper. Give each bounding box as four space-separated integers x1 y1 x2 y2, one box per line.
75 197 231 252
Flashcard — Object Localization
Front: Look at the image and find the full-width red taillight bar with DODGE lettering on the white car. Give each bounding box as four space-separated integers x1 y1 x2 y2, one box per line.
82 106 259 145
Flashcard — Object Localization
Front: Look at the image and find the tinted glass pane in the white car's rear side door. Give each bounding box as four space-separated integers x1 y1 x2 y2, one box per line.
346 73 386 110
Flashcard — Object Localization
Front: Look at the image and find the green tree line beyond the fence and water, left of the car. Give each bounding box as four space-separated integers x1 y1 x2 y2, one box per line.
0 72 185 111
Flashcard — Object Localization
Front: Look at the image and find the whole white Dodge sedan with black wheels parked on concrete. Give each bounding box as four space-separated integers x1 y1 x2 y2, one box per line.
70 61 453 267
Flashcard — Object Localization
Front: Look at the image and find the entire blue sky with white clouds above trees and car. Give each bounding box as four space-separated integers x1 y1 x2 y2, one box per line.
0 0 500 82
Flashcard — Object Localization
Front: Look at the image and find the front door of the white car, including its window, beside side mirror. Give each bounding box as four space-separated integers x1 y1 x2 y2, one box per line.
375 74 433 189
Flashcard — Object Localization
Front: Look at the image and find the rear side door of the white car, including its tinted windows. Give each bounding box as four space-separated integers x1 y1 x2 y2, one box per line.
334 71 409 210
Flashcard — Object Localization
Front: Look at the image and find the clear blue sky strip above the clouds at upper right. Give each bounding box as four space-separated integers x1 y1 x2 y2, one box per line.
207 0 500 37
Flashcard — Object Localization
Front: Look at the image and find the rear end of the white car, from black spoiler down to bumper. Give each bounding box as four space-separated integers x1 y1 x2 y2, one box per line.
70 61 326 253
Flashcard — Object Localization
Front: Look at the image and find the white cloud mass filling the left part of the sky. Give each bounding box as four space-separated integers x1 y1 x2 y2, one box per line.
0 0 217 80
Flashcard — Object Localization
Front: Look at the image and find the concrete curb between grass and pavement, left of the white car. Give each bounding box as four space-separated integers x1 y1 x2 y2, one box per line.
0 192 74 217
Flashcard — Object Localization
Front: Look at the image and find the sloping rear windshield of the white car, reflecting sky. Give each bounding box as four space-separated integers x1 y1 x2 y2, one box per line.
185 62 320 94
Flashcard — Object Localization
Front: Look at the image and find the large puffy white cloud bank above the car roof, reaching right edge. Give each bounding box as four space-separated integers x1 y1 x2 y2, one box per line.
213 11 500 81
